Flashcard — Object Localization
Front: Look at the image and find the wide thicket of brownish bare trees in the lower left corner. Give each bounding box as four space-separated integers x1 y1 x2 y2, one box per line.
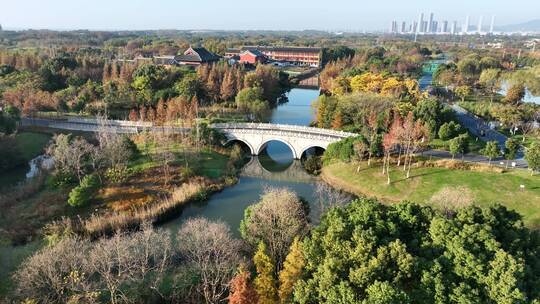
14 223 174 303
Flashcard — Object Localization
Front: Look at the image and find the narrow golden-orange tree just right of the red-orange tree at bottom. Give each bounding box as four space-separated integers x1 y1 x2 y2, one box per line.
253 242 278 304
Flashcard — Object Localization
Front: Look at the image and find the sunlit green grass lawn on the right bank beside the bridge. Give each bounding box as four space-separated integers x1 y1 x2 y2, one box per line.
322 162 540 228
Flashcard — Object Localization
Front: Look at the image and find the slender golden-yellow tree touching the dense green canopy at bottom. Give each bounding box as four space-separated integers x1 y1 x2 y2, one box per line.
278 238 306 304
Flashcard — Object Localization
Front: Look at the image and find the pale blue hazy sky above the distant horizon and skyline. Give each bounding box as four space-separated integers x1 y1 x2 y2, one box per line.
0 0 540 30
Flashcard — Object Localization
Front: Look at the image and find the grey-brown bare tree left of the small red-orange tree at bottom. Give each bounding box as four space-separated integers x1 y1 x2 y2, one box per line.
177 218 241 303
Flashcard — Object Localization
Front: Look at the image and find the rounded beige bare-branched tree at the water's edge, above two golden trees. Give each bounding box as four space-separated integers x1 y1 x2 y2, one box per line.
240 188 308 273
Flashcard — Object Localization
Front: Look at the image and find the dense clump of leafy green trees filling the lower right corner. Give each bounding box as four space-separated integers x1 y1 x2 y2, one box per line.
294 199 540 303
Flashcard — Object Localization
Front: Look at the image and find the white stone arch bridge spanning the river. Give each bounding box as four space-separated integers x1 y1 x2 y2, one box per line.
212 123 356 159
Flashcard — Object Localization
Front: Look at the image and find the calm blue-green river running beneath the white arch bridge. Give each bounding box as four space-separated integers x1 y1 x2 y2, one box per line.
165 88 319 236
